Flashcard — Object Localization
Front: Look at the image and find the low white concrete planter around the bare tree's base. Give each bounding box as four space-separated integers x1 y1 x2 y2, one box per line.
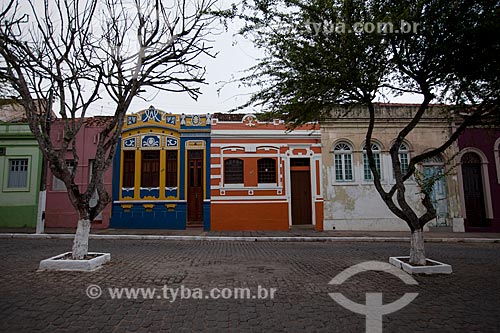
38 252 111 272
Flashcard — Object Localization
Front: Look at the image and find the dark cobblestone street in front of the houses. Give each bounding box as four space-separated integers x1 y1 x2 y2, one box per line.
0 239 500 332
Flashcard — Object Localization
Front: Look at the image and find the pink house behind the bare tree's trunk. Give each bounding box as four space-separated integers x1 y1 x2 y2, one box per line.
45 116 113 228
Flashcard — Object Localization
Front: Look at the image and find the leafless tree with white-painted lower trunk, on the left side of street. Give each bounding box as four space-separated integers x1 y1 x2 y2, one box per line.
0 0 218 259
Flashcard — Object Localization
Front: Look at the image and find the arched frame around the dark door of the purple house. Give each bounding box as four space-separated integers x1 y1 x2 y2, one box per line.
457 147 493 223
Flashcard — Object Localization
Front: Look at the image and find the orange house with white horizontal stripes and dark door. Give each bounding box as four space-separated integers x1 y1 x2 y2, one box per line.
210 114 323 231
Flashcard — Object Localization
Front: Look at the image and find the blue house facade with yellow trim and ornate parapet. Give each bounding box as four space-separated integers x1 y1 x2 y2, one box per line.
110 106 211 230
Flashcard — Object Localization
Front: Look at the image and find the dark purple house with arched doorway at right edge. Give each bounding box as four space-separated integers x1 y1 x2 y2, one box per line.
457 128 500 232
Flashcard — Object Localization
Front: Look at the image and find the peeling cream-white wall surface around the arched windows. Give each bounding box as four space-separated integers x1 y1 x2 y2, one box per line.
321 105 463 231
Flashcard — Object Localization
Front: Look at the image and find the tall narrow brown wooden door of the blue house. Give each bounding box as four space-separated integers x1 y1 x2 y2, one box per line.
187 150 203 225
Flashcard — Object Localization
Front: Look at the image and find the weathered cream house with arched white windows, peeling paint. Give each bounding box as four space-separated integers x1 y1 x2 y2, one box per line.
321 104 464 231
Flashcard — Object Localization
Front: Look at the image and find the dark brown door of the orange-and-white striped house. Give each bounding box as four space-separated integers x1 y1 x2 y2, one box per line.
290 170 312 225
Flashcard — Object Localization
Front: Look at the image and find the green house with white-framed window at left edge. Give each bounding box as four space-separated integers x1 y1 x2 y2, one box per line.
0 103 42 228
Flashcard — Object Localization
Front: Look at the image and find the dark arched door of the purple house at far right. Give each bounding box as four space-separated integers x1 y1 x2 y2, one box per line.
462 153 486 227
